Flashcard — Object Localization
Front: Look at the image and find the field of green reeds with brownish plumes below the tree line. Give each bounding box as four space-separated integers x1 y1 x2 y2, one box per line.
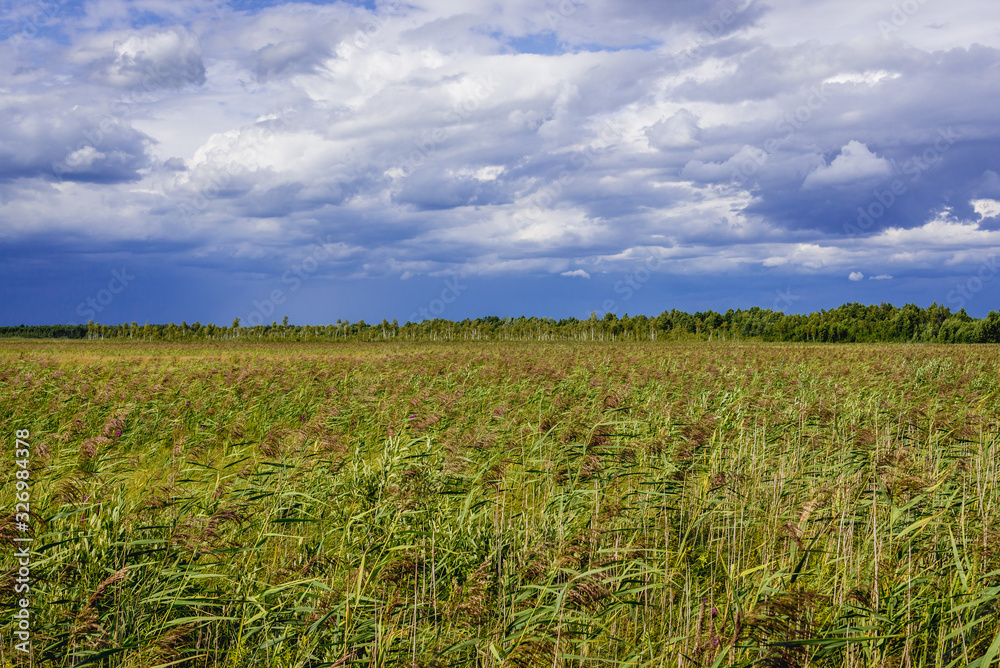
0 341 1000 668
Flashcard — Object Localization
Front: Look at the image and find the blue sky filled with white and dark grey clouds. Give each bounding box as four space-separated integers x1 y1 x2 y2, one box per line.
0 0 1000 325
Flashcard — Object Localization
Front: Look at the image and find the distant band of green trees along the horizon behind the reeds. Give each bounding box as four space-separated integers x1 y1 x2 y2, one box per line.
0 303 1000 343
